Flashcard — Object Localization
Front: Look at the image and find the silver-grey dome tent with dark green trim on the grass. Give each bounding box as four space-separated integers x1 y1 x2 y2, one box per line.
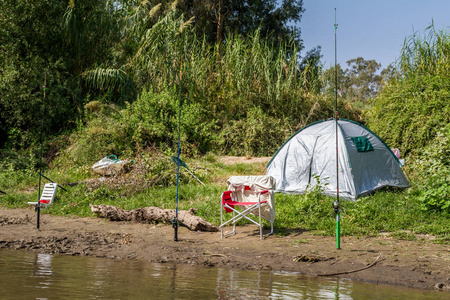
266 119 409 200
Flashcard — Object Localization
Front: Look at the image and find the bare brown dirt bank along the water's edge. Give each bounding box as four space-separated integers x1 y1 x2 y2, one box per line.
0 208 450 292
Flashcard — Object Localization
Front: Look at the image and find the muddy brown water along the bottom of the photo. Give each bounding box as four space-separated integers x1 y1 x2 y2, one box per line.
0 249 450 300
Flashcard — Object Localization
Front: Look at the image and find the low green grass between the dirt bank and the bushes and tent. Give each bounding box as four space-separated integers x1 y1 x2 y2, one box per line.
0 155 450 240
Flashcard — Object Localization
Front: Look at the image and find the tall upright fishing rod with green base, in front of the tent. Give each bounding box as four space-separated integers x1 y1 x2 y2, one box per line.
333 8 341 250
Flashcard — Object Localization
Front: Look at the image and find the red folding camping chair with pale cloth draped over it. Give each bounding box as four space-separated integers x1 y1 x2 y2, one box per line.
219 175 275 239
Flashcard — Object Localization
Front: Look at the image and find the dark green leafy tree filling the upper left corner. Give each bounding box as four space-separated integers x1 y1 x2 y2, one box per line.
0 0 123 147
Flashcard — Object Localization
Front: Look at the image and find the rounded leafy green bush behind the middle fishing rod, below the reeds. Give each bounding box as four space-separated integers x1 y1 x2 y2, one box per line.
123 89 214 156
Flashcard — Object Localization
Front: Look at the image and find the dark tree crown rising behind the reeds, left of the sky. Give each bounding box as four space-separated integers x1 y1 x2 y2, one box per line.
156 0 304 50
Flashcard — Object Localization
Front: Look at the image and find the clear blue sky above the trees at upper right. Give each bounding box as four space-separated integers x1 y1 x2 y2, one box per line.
299 0 450 69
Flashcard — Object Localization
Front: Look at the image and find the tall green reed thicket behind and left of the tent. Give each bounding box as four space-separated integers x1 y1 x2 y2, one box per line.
81 7 359 156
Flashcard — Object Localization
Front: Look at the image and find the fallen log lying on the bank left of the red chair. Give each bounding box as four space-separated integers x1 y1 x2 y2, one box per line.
89 204 219 232
